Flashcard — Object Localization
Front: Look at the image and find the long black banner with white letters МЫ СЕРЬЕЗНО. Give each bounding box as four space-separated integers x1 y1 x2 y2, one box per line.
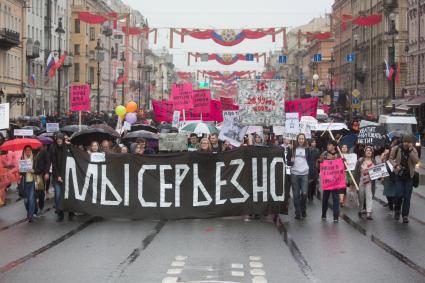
61 147 287 219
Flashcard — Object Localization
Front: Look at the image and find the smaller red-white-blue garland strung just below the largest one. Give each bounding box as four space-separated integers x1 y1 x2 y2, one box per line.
187 52 266 66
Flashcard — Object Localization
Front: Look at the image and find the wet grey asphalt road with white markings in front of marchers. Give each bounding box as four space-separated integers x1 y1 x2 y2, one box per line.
0 184 425 283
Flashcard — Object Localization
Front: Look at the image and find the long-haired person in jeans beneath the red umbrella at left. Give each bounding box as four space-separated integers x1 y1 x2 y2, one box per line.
20 146 36 222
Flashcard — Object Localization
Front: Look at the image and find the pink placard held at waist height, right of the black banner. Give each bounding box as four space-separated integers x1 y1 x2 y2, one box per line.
320 158 347 191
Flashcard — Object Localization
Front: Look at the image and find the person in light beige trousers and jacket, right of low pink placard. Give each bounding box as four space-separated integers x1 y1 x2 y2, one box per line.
354 145 376 220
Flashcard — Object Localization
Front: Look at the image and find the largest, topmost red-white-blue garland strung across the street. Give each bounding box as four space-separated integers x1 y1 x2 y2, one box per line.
170 28 287 48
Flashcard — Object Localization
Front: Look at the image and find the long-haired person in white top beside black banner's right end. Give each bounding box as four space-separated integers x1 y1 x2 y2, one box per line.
291 134 310 220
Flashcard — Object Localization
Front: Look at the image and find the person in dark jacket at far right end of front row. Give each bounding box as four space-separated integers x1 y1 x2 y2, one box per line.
390 135 419 223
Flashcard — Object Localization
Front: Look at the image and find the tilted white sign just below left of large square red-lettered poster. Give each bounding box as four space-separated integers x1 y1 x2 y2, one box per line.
218 111 248 147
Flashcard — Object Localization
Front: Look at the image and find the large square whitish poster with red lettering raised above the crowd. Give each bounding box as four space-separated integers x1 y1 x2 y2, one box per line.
238 80 285 126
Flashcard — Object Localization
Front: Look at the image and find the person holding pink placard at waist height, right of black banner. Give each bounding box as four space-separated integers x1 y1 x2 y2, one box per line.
319 140 341 222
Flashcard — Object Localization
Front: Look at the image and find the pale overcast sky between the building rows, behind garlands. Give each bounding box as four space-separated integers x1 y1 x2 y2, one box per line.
123 0 334 71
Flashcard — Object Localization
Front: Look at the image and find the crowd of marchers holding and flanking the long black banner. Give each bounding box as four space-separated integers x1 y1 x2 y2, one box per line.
0 118 419 223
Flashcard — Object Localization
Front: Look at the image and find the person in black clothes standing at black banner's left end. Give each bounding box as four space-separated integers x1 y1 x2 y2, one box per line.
50 133 67 221
